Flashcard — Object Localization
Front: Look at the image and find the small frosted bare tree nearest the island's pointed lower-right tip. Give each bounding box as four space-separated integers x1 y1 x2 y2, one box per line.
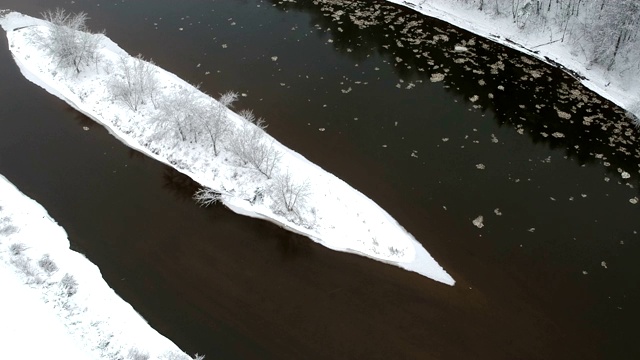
271 169 311 219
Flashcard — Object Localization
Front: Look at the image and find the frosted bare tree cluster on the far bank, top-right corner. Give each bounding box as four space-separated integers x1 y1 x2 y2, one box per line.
458 0 640 77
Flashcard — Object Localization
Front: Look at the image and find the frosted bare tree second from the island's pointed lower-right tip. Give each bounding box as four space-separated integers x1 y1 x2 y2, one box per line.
228 111 282 179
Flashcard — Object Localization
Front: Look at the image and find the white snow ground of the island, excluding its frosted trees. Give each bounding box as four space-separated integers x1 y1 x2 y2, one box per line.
1 13 455 285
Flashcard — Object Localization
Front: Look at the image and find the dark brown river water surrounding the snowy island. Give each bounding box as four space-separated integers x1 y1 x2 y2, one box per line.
0 0 640 359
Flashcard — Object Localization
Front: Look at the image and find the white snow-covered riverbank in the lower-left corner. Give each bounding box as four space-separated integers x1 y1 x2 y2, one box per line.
0 175 190 360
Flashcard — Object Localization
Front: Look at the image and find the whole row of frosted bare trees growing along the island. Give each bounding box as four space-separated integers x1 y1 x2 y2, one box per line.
37 9 311 226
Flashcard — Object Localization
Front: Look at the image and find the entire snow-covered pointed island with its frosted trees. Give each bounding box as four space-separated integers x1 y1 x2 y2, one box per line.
2 12 455 285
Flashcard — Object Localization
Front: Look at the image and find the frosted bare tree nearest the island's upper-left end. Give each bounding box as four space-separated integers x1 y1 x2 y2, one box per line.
36 8 100 74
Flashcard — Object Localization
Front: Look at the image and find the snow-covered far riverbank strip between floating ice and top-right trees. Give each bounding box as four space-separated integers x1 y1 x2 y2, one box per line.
387 0 640 122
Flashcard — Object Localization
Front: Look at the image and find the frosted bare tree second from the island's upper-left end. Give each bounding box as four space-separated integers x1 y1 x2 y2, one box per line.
108 54 158 111
